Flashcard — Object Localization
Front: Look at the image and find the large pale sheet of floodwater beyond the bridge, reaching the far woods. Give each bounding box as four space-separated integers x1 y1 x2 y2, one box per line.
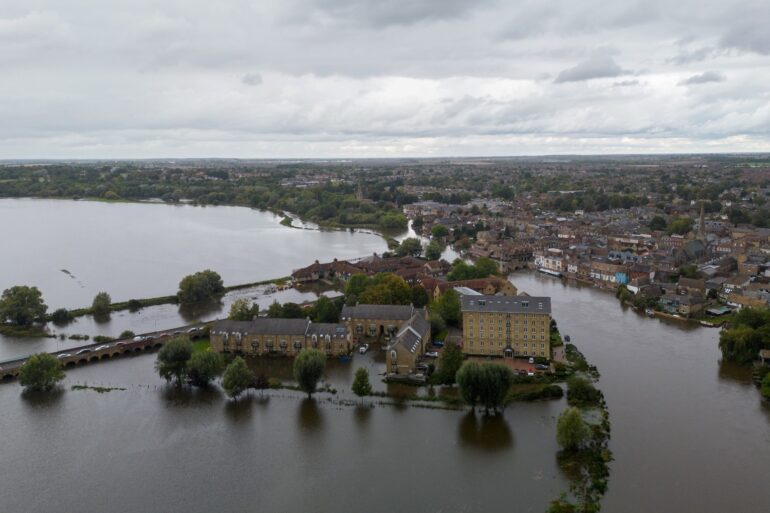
0 199 387 311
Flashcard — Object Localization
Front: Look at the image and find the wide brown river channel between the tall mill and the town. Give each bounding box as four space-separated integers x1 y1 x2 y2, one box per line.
511 272 770 513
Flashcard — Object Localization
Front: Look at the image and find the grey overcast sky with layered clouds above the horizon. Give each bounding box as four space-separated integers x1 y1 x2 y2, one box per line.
0 0 770 158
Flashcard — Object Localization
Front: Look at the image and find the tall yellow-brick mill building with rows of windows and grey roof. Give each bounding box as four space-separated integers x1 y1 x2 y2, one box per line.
461 296 551 358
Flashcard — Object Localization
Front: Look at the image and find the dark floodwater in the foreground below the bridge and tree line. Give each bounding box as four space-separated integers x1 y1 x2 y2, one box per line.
0 340 568 513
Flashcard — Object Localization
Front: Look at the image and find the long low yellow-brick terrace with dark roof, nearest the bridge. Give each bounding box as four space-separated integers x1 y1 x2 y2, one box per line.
211 318 353 356
